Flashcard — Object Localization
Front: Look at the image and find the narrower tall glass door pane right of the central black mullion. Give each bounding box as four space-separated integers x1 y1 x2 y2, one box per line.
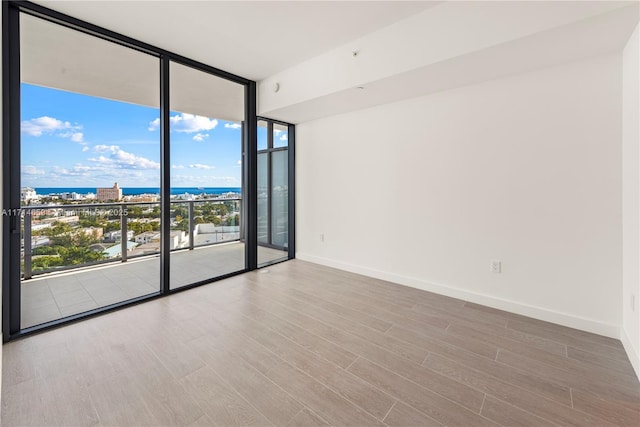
169 62 245 289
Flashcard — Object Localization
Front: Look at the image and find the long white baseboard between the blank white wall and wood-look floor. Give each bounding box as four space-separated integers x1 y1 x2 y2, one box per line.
296 252 624 340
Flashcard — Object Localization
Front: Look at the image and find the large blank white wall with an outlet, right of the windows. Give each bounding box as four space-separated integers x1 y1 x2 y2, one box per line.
296 54 622 338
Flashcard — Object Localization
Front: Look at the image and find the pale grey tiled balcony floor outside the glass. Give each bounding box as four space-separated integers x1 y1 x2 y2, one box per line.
21 242 286 328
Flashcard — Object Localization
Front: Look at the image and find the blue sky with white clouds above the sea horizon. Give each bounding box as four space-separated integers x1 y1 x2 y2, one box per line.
21 83 242 187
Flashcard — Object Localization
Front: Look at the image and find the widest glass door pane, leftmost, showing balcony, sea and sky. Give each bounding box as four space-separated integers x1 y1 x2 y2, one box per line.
16 14 161 329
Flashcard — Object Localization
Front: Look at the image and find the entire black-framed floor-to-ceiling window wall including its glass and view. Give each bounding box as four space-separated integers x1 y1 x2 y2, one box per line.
2 1 294 340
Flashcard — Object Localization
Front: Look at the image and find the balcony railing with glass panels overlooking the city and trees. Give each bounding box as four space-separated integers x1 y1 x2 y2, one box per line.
20 198 242 280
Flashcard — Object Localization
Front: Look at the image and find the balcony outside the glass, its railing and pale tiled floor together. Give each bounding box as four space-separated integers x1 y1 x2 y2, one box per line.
21 198 287 328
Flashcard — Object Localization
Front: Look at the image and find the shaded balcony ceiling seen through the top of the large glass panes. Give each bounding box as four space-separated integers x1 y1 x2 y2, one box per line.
20 14 244 122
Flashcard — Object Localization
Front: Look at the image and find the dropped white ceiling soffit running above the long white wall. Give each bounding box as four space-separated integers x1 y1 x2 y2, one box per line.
258 2 640 123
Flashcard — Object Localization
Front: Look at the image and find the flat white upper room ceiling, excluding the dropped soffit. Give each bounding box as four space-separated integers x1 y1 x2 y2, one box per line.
35 0 440 80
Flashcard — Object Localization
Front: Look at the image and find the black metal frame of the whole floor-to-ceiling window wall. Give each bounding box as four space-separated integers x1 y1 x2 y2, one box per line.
2 0 295 342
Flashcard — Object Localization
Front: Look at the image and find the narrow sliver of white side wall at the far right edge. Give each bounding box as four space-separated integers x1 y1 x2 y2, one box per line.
621 23 640 377
